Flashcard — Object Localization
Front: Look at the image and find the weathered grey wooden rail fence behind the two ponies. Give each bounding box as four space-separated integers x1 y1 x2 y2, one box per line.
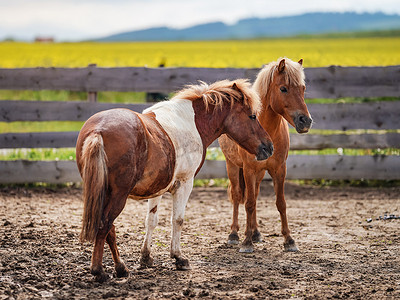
0 66 400 183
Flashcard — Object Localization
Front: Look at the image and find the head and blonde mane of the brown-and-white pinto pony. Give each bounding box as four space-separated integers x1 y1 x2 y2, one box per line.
174 79 273 160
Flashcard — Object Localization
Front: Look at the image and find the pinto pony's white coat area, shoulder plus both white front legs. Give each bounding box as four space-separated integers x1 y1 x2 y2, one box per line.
142 98 203 267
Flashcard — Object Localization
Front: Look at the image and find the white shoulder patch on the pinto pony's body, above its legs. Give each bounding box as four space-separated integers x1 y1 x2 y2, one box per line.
143 98 203 182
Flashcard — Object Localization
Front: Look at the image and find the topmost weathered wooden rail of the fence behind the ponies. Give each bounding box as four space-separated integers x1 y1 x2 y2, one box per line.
0 66 400 98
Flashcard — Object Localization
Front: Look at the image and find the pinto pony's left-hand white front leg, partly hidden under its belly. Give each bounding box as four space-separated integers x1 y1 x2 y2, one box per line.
140 196 162 268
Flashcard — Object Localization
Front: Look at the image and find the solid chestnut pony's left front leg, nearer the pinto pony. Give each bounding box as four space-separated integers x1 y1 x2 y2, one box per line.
239 168 265 252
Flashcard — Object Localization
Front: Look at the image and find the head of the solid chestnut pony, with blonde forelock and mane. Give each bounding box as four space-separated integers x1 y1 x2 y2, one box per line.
254 58 312 133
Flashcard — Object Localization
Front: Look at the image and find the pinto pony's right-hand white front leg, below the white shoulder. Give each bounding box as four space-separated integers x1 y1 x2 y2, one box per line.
171 178 193 270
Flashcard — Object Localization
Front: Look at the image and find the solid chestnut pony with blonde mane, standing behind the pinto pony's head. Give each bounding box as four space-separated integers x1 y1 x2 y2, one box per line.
219 58 312 252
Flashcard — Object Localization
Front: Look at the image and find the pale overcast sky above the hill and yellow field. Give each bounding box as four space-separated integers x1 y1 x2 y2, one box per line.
0 0 400 41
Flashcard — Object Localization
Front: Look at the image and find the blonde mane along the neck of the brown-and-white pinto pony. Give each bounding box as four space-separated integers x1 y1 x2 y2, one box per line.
174 79 261 113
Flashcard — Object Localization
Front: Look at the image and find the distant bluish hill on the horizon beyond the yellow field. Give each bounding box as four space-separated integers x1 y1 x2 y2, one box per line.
96 13 400 42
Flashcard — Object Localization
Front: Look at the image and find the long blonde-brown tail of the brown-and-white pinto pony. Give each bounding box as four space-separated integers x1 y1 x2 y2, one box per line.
80 133 108 242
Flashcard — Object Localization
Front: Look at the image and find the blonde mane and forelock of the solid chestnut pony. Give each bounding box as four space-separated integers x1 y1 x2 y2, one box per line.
253 57 305 102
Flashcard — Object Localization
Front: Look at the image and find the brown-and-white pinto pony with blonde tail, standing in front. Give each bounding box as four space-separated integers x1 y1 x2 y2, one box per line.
76 79 273 282
